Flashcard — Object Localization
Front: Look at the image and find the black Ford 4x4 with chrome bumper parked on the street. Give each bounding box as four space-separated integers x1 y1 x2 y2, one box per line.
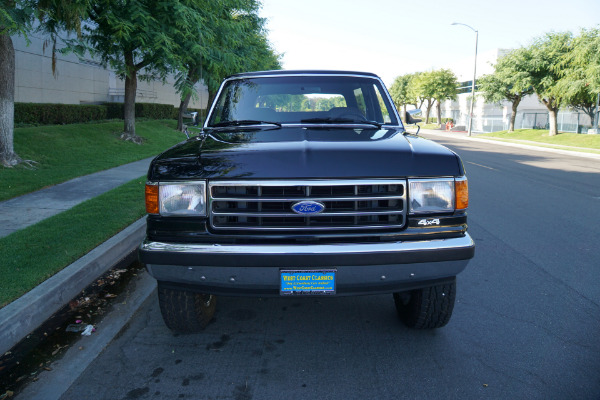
139 71 475 332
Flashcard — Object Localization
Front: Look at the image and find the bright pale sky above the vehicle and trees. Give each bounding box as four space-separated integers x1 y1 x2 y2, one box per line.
261 0 600 86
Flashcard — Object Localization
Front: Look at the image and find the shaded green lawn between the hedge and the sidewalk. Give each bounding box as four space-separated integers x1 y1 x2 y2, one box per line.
0 120 185 201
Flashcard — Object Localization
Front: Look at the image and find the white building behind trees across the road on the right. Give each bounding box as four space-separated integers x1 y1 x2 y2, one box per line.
442 49 591 132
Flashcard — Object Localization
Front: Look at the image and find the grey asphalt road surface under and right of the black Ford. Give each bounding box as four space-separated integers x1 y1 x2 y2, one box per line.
57 135 600 400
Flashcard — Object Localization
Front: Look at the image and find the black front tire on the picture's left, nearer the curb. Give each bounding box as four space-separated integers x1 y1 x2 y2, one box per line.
158 282 217 333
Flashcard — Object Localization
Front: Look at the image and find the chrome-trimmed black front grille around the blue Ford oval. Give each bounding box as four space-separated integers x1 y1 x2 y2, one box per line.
209 179 406 231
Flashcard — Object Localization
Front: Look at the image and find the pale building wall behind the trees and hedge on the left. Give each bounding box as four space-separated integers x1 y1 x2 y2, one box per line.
12 35 208 108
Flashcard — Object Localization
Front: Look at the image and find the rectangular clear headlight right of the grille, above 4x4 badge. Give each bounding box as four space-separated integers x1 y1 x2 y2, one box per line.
408 178 454 214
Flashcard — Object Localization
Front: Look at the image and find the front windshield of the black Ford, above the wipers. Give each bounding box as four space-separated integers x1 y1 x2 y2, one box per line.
207 75 398 127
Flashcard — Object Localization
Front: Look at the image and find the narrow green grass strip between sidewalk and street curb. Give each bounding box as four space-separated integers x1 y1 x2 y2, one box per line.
0 177 146 307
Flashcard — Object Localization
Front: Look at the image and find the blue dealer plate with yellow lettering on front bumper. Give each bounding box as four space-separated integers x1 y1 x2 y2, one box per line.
280 269 337 296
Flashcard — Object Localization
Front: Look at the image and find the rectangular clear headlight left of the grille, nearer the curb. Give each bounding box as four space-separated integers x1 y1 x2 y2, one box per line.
158 182 206 217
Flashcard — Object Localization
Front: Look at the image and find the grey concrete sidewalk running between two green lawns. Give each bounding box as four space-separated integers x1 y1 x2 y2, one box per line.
0 157 154 238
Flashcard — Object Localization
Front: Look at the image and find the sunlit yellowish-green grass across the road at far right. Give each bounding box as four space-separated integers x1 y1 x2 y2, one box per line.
477 129 600 150
